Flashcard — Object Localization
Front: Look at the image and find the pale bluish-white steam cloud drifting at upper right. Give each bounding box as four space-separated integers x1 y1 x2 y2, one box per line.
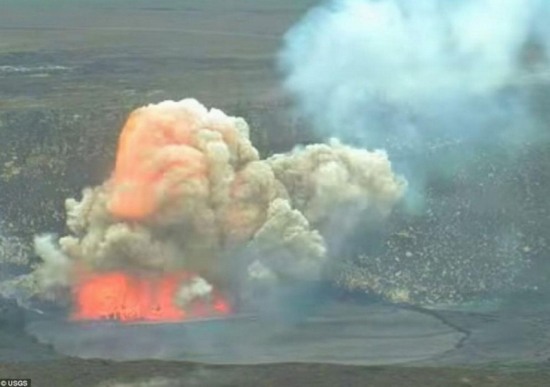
280 0 550 150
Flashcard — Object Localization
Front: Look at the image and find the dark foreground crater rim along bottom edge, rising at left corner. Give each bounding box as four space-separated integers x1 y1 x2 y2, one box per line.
0 300 550 387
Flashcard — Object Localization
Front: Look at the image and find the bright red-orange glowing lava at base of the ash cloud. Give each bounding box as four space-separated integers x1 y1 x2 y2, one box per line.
72 272 231 322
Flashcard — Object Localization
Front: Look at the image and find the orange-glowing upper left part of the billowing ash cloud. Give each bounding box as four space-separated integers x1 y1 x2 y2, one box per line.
108 105 207 220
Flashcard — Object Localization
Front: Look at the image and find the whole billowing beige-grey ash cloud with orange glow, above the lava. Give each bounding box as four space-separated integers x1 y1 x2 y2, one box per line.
30 99 405 312
